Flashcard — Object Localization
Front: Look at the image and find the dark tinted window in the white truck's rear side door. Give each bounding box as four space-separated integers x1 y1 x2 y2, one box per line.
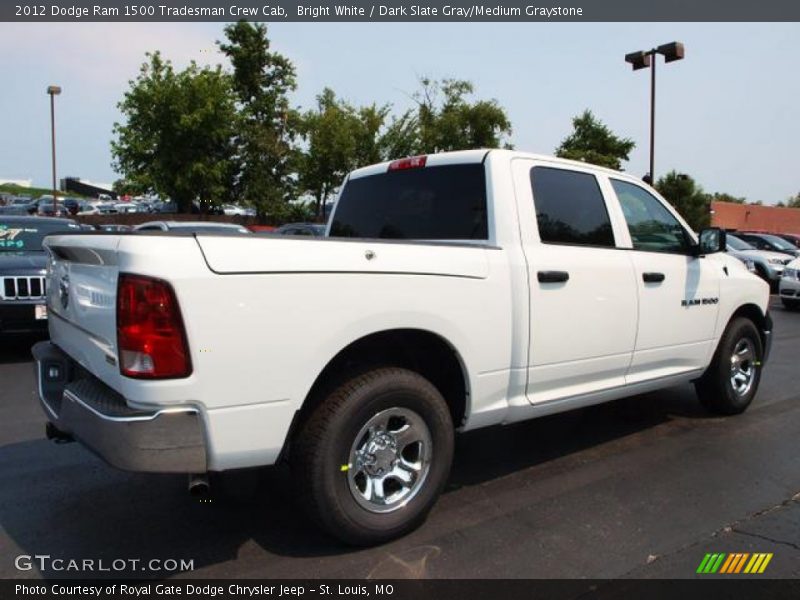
531 167 614 246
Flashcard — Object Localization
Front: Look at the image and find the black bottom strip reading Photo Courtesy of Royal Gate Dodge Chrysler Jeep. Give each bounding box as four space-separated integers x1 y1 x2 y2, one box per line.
0 580 800 600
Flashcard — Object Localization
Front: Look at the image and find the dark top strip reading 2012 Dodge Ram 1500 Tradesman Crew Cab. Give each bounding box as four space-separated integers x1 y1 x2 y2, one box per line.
0 0 800 23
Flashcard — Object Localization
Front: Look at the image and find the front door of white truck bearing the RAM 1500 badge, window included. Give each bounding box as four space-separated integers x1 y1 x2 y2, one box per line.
609 177 722 383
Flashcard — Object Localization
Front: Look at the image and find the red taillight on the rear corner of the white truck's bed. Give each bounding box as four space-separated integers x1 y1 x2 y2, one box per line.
117 274 192 379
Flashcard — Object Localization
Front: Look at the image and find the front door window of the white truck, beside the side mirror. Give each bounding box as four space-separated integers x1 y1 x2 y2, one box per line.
611 179 692 253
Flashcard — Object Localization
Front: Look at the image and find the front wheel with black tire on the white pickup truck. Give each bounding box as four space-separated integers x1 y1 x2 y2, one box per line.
695 317 764 415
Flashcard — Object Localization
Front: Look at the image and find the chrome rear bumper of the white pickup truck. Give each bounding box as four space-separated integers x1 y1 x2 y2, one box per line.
33 342 207 473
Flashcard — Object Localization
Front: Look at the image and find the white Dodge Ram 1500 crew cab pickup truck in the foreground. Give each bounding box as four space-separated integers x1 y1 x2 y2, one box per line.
33 150 772 544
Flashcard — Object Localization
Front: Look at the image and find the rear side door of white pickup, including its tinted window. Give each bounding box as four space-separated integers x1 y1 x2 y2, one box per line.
512 159 638 403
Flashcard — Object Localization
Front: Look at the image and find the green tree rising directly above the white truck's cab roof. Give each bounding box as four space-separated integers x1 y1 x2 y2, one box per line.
406 78 511 156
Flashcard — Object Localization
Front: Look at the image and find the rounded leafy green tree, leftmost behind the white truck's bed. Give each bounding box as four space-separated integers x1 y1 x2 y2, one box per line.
111 52 236 212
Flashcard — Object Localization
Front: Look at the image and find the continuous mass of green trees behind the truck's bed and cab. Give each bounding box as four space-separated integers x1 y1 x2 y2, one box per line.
111 21 511 222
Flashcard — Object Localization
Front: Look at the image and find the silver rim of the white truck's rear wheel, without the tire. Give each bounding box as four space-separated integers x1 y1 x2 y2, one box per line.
347 407 433 513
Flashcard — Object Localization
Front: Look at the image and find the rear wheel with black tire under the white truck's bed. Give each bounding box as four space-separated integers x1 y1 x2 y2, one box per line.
290 368 454 546
